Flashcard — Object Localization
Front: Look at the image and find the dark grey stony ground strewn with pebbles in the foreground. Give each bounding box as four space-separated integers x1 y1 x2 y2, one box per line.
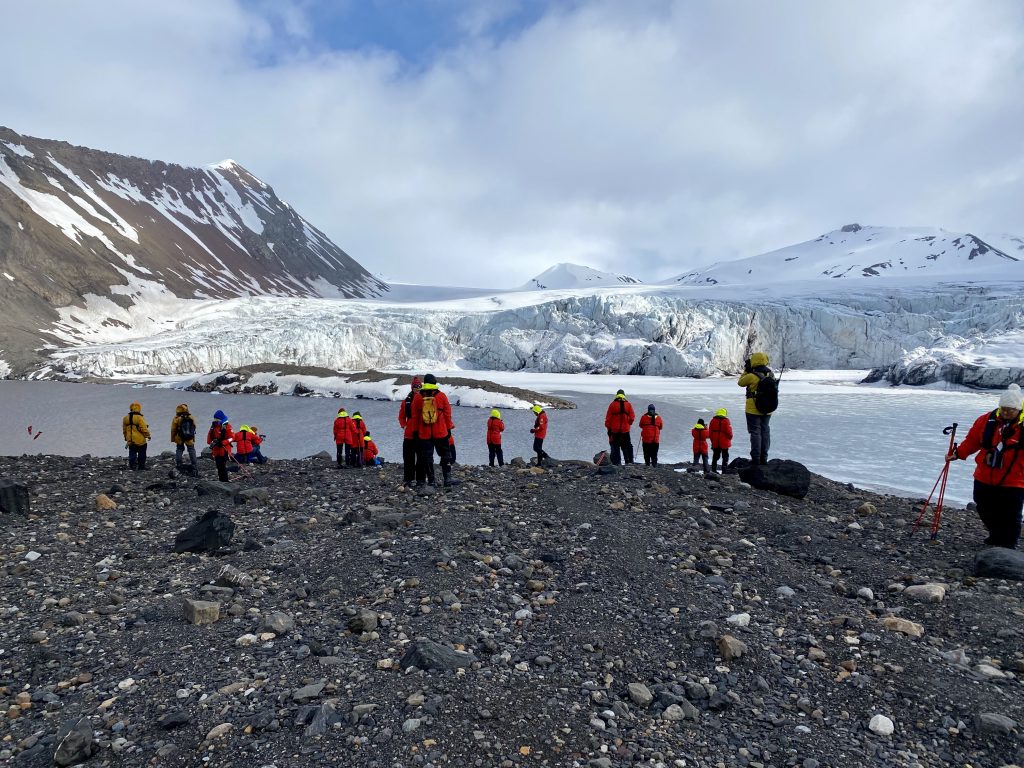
0 456 1024 768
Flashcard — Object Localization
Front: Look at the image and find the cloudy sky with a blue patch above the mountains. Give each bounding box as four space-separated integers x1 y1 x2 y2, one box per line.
0 0 1024 287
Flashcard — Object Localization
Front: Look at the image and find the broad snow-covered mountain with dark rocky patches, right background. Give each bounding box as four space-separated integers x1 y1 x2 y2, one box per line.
667 224 1024 286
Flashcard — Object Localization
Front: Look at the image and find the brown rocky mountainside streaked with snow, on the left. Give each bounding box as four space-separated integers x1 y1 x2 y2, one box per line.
0 127 388 372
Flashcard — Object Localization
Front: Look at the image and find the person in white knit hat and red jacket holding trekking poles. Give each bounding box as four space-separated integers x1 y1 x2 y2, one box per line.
946 384 1024 549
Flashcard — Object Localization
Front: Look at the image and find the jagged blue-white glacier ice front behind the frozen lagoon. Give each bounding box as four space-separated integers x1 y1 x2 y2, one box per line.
44 281 1024 387
